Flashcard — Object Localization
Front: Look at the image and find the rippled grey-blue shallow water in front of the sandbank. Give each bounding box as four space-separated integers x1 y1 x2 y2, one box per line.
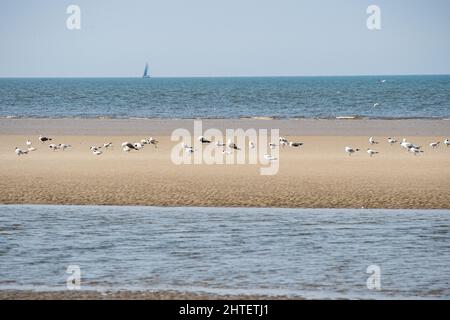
0 205 450 299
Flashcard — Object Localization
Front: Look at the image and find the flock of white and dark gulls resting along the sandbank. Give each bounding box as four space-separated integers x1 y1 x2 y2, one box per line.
15 136 450 161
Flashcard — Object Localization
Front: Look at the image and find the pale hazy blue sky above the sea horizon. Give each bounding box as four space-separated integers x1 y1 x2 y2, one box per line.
0 0 450 77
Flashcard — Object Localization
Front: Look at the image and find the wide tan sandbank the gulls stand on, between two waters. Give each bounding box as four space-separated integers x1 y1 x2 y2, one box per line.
0 119 450 209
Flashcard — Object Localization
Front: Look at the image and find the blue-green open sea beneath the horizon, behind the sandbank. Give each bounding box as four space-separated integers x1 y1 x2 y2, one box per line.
0 75 450 119
